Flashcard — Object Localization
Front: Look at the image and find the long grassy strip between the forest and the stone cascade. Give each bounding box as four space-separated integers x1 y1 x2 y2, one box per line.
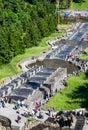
0 25 71 82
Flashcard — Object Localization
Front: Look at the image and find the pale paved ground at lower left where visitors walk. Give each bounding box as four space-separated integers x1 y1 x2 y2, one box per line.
0 103 49 128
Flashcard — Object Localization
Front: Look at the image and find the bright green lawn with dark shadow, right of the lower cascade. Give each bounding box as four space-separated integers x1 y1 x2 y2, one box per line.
45 72 88 110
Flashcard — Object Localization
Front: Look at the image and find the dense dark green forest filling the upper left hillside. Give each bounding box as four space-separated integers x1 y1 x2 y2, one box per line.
0 0 83 64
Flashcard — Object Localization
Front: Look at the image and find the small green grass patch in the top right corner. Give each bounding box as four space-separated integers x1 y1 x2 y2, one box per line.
73 0 88 10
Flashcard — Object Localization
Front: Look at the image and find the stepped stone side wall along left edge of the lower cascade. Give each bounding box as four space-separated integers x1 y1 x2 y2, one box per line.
0 65 43 97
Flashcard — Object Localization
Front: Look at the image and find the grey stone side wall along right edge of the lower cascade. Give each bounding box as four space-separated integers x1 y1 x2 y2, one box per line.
39 68 67 98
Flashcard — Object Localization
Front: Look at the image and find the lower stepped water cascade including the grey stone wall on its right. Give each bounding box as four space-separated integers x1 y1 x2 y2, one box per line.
8 68 67 102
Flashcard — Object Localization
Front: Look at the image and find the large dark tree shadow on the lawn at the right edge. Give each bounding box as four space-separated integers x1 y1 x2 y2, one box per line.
67 83 88 108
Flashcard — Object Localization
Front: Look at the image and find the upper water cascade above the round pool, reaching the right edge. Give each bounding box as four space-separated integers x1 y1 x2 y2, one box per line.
45 23 88 60
